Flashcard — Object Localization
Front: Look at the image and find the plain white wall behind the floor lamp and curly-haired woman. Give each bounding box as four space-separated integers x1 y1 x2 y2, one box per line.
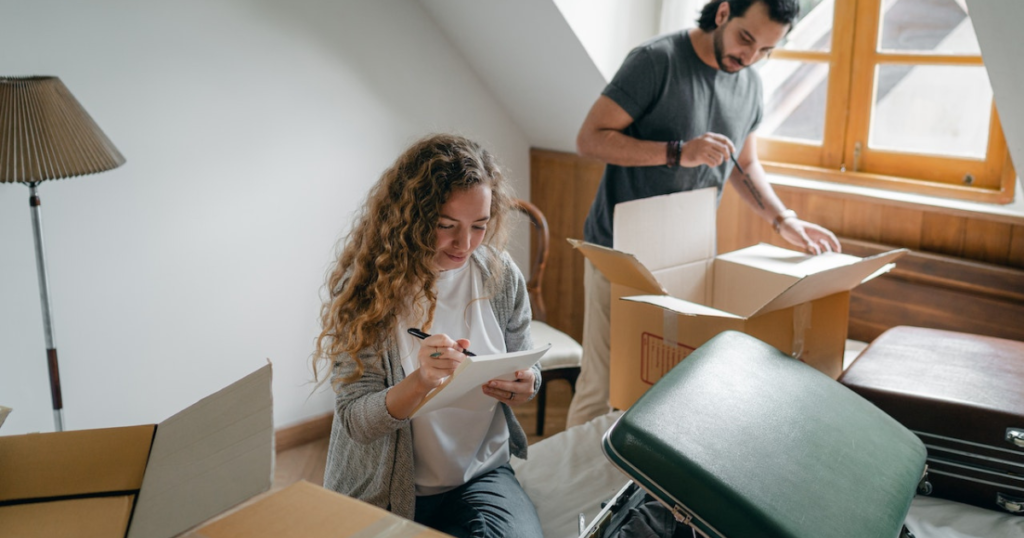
0 0 529 434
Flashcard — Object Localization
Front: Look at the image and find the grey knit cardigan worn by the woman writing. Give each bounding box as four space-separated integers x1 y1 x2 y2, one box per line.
324 246 541 520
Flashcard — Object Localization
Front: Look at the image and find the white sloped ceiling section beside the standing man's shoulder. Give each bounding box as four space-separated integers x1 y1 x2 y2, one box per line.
420 0 605 153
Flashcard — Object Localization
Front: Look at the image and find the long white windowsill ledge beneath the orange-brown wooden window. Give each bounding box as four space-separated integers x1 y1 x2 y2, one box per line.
767 173 1024 225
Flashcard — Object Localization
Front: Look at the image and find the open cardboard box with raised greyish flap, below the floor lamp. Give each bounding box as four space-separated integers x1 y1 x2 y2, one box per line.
0 364 274 538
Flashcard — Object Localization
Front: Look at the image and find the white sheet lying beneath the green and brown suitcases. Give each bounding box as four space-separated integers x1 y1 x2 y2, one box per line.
512 413 1024 538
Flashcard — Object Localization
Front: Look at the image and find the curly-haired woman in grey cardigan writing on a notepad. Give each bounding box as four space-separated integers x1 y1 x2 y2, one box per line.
313 134 541 537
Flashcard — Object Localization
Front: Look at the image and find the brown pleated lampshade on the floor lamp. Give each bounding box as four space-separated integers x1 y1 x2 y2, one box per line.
0 77 125 183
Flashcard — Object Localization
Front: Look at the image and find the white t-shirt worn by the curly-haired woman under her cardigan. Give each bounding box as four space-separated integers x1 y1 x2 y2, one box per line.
396 260 511 495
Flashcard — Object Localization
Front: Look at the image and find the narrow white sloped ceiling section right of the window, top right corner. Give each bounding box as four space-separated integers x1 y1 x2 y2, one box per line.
967 0 1024 180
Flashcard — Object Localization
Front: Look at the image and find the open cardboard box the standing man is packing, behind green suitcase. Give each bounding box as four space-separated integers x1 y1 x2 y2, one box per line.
569 189 906 409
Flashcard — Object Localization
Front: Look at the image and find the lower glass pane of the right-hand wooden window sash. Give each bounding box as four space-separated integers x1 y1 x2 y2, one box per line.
868 66 992 159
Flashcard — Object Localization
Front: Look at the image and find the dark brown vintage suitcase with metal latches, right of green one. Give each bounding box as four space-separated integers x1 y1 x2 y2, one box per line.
841 327 1024 513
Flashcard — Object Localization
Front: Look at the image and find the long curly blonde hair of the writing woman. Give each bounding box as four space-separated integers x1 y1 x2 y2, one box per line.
312 134 513 390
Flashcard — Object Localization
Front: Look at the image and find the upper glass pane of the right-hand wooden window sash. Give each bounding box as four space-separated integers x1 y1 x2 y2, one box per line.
879 0 981 54
